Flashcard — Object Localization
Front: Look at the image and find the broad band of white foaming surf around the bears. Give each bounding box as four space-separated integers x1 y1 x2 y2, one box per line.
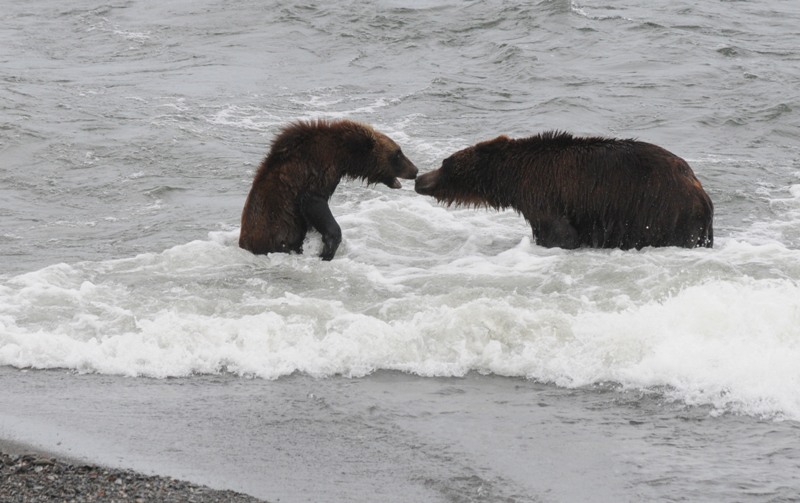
0 184 800 418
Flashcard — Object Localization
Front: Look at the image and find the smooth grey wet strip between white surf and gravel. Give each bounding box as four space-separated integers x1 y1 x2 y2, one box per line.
0 367 800 503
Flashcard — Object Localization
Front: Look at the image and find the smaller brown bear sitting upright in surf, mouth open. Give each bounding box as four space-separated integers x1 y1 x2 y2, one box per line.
239 120 417 260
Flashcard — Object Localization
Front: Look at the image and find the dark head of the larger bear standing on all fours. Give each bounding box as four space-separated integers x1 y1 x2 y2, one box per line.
414 136 511 208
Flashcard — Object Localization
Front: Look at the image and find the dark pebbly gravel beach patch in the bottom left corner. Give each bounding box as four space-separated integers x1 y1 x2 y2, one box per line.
0 451 262 503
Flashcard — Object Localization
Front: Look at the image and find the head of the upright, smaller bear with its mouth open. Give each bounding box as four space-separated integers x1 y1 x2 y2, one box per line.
339 121 418 189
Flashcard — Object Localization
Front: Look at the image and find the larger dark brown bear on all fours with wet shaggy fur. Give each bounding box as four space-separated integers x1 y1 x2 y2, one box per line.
415 132 714 250
